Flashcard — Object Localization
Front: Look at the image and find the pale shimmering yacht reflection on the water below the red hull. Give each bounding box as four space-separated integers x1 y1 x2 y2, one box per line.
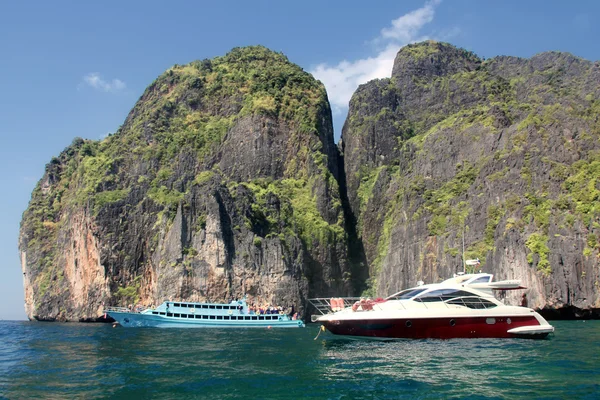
324 339 550 397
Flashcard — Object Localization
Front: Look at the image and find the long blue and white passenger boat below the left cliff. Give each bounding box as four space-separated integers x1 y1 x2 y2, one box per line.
104 300 304 328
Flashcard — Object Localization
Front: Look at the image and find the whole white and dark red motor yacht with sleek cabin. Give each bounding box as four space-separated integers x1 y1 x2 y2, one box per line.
311 273 554 339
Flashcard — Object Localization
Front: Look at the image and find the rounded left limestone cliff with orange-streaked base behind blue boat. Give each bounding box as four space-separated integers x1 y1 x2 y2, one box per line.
19 47 354 320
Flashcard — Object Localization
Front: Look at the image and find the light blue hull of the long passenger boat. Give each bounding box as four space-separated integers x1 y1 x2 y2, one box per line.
108 311 304 328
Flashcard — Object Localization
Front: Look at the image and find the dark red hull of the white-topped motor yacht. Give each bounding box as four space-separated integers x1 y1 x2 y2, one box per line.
322 315 548 339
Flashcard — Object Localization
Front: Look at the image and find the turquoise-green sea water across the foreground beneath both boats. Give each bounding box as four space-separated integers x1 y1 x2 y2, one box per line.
0 321 600 399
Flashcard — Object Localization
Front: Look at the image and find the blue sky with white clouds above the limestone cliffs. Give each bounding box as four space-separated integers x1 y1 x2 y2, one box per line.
0 0 600 320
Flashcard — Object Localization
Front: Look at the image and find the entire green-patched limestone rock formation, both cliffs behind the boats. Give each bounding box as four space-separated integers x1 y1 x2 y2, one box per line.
19 42 600 320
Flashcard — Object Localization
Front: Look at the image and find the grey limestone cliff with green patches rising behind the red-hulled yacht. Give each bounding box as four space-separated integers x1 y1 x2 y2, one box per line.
342 42 600 315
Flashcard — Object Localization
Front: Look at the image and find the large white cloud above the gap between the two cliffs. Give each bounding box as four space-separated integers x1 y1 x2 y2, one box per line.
310 0 446 114
